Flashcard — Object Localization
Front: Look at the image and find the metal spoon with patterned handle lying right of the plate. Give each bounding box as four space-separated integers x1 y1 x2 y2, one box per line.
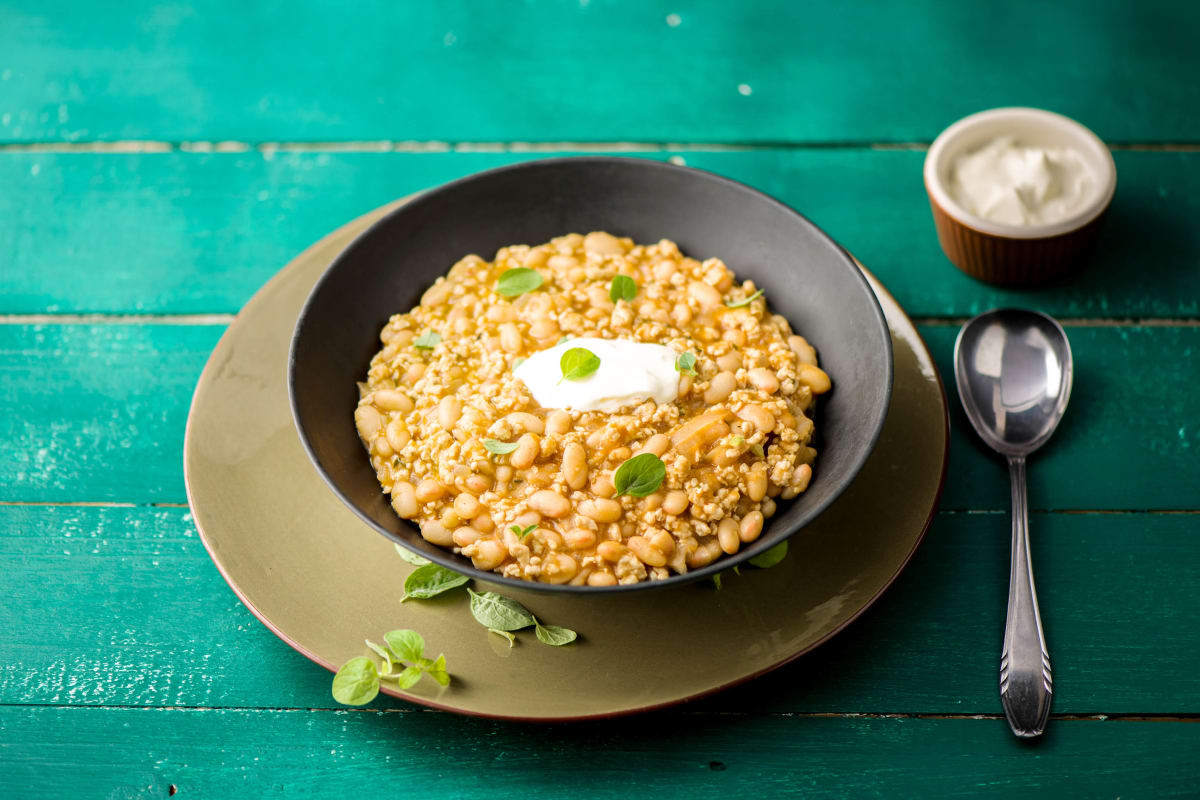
954 308 1072 738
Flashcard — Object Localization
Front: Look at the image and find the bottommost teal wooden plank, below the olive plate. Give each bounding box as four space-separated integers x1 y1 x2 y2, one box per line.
0 708 1200 800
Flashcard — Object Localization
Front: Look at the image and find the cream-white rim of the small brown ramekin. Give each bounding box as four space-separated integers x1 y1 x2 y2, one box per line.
923 106 1117 239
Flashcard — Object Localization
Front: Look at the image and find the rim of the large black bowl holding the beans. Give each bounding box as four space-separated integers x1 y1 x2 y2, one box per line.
287 156 895 596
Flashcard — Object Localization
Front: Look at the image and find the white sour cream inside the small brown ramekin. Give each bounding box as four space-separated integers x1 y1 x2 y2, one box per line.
950 136 1096 225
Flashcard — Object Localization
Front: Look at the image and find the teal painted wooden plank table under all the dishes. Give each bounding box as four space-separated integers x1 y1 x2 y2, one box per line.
0 0 1200 799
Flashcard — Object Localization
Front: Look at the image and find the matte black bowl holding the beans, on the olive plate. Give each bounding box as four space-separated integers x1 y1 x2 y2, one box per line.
288 158 892 594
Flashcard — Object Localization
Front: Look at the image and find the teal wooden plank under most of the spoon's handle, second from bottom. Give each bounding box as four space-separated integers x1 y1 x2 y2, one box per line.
0 506 1200 714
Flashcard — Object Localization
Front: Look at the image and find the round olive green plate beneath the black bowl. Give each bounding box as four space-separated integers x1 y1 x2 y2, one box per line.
184 199 948 720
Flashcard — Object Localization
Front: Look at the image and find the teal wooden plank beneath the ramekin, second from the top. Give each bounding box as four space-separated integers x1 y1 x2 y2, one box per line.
0 149 1200 318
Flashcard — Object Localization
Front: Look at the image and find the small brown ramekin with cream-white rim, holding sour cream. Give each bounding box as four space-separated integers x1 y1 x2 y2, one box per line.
924 108 1116 285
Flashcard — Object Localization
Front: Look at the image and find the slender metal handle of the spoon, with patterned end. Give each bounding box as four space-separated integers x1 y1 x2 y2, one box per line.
1000 456 1054 738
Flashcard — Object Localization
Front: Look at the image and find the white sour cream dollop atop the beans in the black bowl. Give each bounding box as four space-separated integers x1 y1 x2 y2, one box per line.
512 337 679 411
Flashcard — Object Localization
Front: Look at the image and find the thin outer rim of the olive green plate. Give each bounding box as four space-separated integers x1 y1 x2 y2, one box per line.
184 201 950 723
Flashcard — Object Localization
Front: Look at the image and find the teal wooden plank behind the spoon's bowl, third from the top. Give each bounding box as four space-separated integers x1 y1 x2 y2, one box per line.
0 324 1200 510
